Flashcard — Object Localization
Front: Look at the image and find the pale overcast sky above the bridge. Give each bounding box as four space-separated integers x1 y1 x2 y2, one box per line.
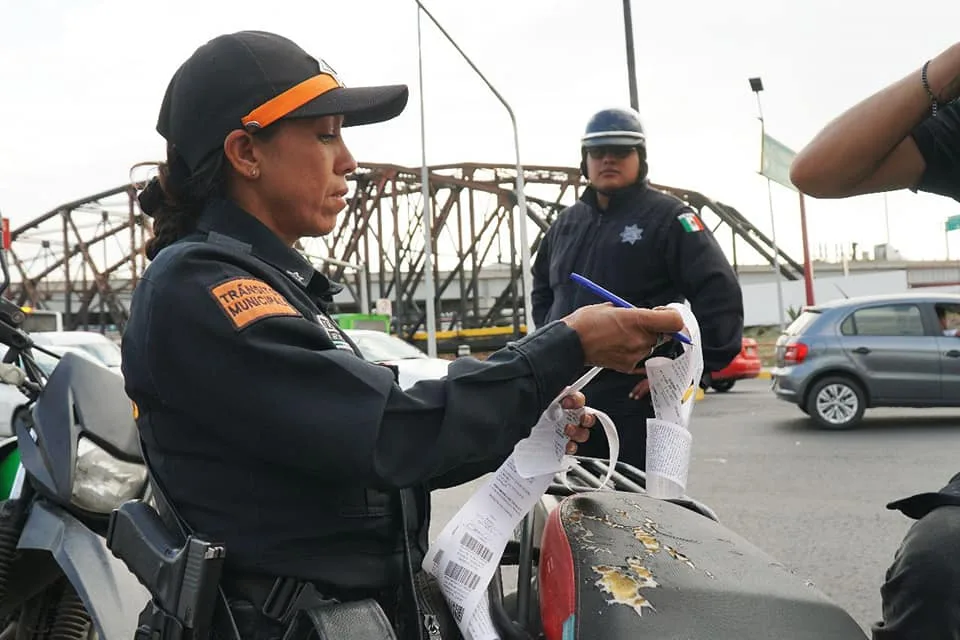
0 0 960 268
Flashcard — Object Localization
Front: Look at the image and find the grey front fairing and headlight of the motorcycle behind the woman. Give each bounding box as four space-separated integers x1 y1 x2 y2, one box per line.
17 353 141 500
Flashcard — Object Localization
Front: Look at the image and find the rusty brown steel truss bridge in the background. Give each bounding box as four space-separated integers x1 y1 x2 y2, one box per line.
5 163 803 348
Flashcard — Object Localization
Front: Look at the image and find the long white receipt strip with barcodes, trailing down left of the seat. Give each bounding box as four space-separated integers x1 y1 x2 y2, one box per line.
423 305 699 640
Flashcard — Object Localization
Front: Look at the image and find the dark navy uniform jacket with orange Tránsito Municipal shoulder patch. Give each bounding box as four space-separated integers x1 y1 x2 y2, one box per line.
123 196 584 588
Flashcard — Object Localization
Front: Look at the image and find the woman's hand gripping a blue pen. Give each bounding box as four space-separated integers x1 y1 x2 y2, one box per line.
563 302 683 373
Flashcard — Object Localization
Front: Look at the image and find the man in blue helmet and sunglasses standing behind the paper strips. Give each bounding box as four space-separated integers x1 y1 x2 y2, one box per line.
531 109 743 469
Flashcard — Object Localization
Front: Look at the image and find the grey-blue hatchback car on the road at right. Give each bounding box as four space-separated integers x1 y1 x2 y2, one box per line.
772 293 960 429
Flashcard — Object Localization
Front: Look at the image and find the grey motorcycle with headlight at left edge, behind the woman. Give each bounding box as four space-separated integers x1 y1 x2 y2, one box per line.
0 246 150 640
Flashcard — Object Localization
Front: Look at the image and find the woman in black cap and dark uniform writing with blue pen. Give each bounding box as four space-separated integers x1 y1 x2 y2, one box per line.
123 31 683 637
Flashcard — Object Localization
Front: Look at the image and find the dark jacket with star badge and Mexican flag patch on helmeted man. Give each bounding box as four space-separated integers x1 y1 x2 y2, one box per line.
532 185 743 402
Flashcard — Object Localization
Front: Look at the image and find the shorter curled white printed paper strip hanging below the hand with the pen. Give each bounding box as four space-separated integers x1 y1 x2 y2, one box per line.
644 303 704 498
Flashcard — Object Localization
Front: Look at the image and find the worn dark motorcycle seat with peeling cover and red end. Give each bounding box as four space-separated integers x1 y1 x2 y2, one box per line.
539 491 866 640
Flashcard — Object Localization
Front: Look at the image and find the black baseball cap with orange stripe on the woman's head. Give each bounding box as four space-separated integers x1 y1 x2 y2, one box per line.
157 31 409 171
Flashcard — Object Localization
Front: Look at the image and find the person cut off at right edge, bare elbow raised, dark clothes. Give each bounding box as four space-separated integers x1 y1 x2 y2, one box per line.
790 42 960 640
